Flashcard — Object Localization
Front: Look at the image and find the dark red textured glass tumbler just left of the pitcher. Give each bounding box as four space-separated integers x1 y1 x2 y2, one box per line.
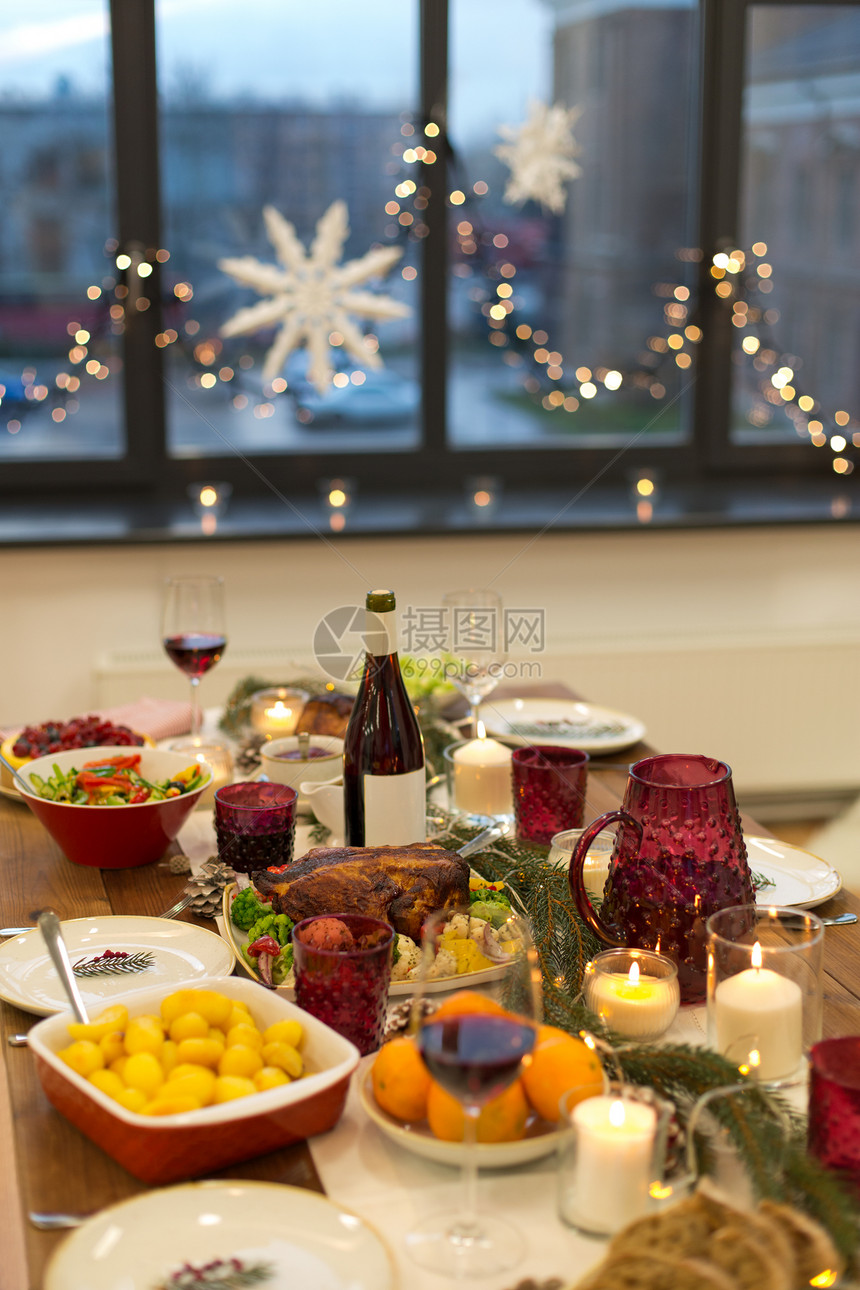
511 744 588 846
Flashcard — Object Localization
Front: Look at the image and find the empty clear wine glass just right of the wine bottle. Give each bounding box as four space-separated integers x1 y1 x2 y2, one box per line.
442 588 504 735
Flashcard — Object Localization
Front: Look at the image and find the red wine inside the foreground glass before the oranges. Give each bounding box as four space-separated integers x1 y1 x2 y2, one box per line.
418 1013 535 1104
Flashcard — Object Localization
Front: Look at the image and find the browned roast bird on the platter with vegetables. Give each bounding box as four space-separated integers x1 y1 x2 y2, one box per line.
253 842 469 940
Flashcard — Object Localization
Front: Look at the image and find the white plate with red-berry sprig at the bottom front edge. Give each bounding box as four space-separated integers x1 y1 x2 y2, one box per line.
45 1179 397 1290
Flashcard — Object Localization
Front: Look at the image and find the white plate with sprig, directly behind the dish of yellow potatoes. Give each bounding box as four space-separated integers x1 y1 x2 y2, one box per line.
0 915 233 1017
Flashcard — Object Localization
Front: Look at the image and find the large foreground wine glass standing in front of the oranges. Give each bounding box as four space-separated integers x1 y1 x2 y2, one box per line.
406 906 540 1280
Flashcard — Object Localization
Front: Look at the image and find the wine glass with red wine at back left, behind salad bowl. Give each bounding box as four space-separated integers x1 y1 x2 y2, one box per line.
161 575 227 743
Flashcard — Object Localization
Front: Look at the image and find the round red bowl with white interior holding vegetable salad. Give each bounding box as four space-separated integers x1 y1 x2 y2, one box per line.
18 747 211 869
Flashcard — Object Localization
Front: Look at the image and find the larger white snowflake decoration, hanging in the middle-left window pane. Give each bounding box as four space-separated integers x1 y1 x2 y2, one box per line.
218 201 411 393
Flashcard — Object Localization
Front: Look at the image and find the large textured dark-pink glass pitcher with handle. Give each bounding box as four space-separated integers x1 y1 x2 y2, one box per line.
570 753 754 1004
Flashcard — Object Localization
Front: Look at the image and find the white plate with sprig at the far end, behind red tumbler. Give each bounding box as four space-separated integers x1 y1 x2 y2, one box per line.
481 697 645 753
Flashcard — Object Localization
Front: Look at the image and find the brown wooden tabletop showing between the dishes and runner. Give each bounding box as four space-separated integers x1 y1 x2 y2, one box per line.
0 712 860 1290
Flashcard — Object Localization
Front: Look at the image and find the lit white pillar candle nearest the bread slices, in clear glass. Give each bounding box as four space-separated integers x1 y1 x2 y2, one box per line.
562 1095 658 1233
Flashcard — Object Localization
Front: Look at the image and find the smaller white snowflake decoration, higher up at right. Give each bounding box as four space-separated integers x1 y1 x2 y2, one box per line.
494 102 581 215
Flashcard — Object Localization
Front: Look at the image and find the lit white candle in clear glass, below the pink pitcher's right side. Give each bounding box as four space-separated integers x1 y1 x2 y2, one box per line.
713 942 803 1080
